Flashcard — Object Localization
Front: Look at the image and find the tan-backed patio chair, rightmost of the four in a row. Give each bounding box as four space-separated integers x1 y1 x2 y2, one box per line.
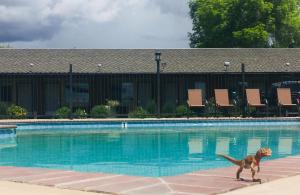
277 88 297 116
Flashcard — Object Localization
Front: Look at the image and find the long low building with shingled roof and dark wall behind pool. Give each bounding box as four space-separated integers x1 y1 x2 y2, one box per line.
0 49 300 116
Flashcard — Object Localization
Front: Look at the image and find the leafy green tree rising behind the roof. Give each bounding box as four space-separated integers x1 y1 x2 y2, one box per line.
189 0 300 47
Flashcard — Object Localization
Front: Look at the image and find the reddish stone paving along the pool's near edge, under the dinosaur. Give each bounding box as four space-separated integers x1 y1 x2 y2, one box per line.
0 156 300 195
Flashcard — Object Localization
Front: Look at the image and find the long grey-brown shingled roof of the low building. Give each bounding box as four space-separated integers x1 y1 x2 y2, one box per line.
0 48 300 73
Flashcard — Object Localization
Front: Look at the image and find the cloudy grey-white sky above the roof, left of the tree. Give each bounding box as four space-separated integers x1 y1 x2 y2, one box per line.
0 0 192 48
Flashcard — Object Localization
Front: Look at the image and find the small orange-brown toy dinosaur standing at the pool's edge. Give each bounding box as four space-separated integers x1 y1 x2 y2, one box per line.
217 148 272 183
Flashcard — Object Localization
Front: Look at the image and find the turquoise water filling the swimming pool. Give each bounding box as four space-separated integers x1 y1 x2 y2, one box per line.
0 122 300 177
